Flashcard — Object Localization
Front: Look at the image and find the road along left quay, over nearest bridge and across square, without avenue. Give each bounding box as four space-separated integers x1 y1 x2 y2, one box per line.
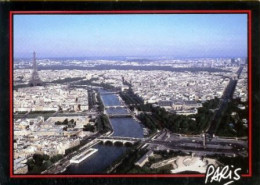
42 123 247 174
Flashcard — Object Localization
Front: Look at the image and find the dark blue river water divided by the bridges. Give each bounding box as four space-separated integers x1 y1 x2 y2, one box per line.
64 91 143 174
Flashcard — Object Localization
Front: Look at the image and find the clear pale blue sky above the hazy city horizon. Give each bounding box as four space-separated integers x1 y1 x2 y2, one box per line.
13 14 247 58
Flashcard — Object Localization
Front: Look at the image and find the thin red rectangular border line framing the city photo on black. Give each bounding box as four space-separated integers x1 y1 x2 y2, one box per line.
9 10 252 178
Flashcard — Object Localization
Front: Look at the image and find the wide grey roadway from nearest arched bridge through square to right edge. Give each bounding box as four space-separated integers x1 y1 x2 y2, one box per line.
99 130 248 156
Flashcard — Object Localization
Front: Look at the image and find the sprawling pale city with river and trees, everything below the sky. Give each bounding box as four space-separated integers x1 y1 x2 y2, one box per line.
13 58 250 175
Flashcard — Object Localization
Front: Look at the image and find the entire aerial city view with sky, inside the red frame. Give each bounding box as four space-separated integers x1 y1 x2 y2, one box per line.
13 14 249 175
